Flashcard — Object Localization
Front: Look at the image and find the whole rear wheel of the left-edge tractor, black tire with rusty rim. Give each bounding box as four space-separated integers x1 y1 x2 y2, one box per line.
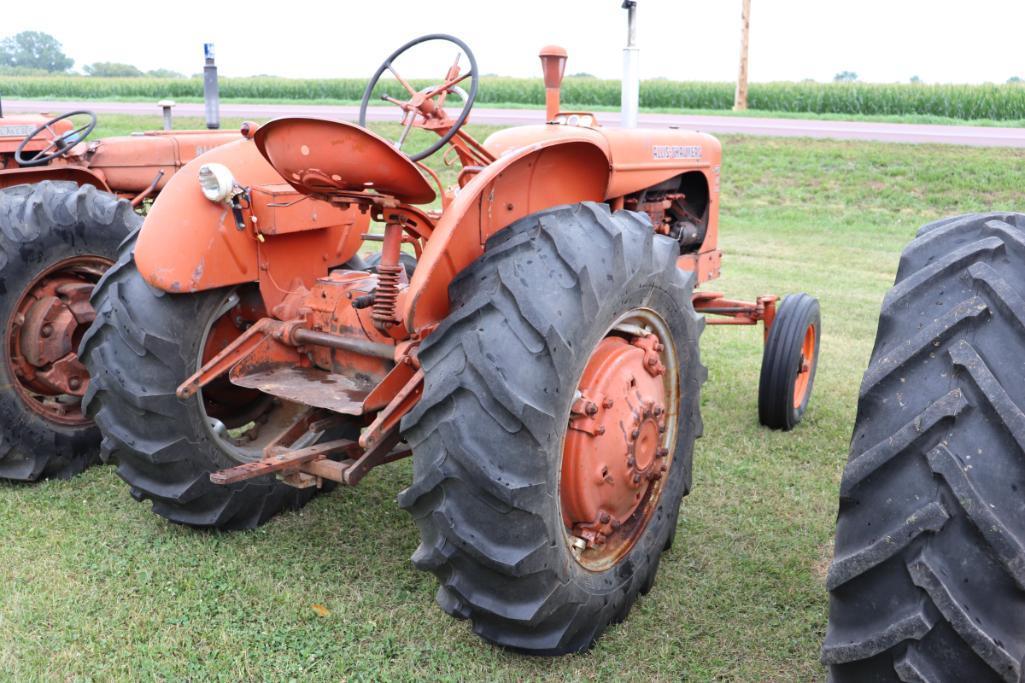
0 180 141 481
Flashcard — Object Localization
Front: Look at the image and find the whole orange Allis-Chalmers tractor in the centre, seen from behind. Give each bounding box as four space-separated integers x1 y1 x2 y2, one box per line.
80 35 819 654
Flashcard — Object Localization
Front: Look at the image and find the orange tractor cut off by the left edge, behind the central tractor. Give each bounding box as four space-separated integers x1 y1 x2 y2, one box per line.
0 106 241 481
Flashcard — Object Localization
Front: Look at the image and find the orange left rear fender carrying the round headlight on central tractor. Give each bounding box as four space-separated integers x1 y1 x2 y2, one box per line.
135 139 369 301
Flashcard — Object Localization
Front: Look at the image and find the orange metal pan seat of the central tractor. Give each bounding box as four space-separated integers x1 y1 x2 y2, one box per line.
253 117 437 204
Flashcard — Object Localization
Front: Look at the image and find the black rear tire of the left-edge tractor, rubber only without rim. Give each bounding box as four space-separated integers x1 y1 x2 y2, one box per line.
0 180 141 481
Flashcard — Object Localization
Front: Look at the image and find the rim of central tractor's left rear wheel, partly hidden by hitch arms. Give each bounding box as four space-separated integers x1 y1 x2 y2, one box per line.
196 289 299 463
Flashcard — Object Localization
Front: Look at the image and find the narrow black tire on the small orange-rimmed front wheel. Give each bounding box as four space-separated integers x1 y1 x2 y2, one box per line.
759 293 822 432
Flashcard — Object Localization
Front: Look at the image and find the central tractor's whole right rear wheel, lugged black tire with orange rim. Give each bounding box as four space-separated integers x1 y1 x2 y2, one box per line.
400 203 707 654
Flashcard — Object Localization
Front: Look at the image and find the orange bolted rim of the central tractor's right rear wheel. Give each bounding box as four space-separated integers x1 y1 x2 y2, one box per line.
559 309 680 571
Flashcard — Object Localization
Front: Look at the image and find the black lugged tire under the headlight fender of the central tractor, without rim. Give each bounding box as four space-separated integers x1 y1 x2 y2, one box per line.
81 236 344 529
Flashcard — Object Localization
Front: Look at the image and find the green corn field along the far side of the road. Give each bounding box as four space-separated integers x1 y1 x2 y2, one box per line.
0 76 1025 120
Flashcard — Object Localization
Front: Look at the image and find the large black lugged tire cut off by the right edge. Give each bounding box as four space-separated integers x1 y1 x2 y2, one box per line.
822 213 1025 681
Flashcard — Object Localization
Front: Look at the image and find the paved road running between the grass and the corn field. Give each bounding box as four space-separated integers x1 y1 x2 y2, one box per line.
3 99 1025 148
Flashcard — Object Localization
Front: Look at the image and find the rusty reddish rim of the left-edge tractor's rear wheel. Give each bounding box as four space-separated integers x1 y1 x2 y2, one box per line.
5 255 113 427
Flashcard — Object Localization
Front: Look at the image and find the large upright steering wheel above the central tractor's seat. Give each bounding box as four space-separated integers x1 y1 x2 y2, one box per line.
360 33 480 161
